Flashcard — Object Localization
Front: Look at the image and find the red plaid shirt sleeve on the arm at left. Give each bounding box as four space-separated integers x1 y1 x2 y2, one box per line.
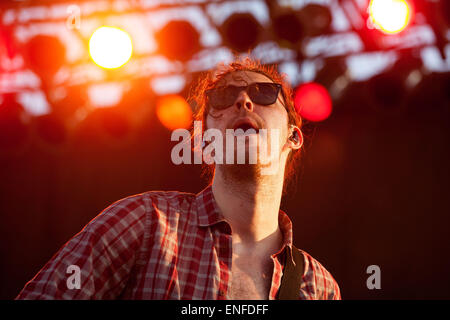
16 196 146 300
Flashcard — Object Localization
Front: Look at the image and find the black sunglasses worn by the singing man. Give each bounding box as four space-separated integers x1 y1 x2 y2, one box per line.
206 82 281 110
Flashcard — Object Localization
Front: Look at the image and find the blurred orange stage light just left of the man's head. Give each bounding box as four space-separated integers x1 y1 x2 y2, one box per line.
156 95 192 130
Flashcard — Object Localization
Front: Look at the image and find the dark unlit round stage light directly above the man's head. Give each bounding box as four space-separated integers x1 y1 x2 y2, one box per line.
220 13 262 52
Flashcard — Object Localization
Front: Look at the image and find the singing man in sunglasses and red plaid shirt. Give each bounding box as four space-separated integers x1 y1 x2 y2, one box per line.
17 59 341 299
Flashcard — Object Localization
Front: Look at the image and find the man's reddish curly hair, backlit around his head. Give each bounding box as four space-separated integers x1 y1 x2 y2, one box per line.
189 57 303 195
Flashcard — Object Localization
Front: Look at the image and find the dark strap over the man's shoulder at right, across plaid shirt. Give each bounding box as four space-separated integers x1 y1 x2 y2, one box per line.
278 246 304 300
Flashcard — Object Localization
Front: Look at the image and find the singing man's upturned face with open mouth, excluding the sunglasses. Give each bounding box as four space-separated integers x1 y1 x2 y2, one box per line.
206 71 289 170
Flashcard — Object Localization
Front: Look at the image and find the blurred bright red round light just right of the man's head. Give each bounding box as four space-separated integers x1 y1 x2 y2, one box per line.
294 82 332 121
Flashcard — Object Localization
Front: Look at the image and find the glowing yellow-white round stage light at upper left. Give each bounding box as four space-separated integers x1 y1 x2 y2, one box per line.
89 26 133 69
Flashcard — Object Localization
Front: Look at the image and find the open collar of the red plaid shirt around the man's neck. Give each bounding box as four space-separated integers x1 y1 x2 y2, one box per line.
196 185 293 259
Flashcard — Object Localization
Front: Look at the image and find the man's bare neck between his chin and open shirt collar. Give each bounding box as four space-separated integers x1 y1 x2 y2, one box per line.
212 165 283 250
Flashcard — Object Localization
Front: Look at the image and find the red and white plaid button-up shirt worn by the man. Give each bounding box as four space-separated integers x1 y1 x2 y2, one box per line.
16 186 341 300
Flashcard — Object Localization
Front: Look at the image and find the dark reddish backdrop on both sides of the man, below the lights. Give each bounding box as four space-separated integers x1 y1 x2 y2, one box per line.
0 71 450 299
